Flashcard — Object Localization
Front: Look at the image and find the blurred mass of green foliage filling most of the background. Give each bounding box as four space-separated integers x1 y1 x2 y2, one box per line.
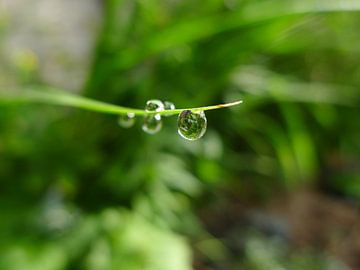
0 0 360 270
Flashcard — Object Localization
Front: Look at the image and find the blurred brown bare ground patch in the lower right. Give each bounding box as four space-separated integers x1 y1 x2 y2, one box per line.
198 187 360 269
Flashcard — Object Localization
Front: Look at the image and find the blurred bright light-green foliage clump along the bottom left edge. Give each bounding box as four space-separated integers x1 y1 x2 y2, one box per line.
0 208 191 270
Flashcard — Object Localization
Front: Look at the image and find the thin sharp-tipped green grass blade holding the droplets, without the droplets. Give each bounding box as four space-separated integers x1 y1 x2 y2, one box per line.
0 88 242 115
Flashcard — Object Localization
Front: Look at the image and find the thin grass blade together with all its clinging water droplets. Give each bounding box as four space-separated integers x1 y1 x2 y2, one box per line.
0 88 242 140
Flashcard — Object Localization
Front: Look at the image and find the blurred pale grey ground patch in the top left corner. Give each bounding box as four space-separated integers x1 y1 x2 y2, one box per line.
0 0 101 90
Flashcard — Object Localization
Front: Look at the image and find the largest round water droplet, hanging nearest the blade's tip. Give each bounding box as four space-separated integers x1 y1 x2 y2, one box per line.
178 110 207 141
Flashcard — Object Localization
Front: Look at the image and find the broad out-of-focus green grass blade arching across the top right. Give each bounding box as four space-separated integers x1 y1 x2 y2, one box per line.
116 0 360 69
